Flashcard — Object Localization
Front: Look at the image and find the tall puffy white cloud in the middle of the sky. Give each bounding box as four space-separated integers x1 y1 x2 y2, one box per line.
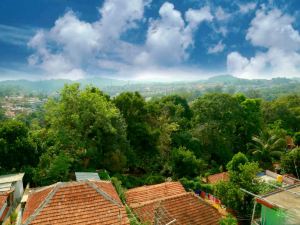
135 2 213 65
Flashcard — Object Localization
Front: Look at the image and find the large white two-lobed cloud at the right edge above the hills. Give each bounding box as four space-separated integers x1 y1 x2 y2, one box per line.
227 8 300 77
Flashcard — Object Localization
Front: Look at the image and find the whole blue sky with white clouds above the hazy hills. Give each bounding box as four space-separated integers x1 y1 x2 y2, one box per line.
0 0 300 81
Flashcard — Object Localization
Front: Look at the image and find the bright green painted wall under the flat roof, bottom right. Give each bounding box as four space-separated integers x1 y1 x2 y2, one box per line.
261 205 286 225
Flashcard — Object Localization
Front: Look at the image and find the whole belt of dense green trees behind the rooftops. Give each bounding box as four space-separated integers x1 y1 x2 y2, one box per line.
0 84 300 187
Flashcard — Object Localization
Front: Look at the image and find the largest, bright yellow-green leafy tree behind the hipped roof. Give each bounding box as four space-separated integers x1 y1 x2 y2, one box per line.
39 84 128 177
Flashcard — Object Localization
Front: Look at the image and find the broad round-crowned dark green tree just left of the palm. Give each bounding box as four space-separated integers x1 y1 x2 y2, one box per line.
192 94 242 163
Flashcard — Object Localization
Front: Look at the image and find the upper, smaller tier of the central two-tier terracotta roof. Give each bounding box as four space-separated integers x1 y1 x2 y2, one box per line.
126 182 186 204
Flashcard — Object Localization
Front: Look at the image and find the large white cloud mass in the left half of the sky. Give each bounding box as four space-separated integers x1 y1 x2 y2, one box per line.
28 0 148 79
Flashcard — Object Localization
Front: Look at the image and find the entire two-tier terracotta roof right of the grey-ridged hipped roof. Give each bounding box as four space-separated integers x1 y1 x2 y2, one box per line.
126 182 221 225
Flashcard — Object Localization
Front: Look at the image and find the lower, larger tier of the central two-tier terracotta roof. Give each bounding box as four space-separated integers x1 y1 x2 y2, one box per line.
132 192 221 225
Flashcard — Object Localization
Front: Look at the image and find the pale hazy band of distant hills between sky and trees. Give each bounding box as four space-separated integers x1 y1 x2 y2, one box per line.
0 75 300 100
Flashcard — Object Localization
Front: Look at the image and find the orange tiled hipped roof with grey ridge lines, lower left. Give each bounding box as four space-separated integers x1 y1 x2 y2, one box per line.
22 181 129 225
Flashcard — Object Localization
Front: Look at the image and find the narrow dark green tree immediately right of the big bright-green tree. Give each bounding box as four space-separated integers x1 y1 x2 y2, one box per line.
113 92 159 170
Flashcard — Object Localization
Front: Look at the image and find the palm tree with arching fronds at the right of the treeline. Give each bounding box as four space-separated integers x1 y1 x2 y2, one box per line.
250 132 286 169
